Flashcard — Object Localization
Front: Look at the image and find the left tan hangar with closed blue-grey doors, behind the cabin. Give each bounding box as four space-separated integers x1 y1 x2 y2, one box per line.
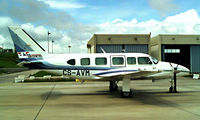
87 34 151 54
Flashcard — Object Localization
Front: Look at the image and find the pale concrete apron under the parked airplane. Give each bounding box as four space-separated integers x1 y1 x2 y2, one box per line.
0 71 200 120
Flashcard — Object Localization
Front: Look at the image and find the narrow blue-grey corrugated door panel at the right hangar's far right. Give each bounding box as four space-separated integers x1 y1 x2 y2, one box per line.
190 45 200 73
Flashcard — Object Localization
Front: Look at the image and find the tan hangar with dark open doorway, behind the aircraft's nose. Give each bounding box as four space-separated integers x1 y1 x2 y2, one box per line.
150 34 200 73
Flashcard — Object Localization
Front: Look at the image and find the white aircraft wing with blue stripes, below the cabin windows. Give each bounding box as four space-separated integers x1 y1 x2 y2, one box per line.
95 69 159 78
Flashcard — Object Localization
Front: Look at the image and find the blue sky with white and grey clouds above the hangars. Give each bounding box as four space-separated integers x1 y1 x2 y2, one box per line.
0 0 200 53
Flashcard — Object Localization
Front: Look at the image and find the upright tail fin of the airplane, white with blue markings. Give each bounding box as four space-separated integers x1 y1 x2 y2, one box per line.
8 26 45 61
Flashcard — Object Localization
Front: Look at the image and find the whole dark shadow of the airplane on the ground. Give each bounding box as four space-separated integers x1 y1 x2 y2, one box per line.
41 88 199 107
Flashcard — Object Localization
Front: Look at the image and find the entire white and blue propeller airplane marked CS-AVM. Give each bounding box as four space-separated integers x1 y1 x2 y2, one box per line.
8 27 189 97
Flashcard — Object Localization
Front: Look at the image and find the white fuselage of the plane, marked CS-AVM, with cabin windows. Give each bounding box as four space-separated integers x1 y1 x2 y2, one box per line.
36 53 189 80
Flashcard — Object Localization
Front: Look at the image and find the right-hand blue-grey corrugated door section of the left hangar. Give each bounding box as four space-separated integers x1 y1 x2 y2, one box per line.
125 45 148 54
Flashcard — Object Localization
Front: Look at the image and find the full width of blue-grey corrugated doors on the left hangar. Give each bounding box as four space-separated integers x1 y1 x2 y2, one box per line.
96 45 148 53
